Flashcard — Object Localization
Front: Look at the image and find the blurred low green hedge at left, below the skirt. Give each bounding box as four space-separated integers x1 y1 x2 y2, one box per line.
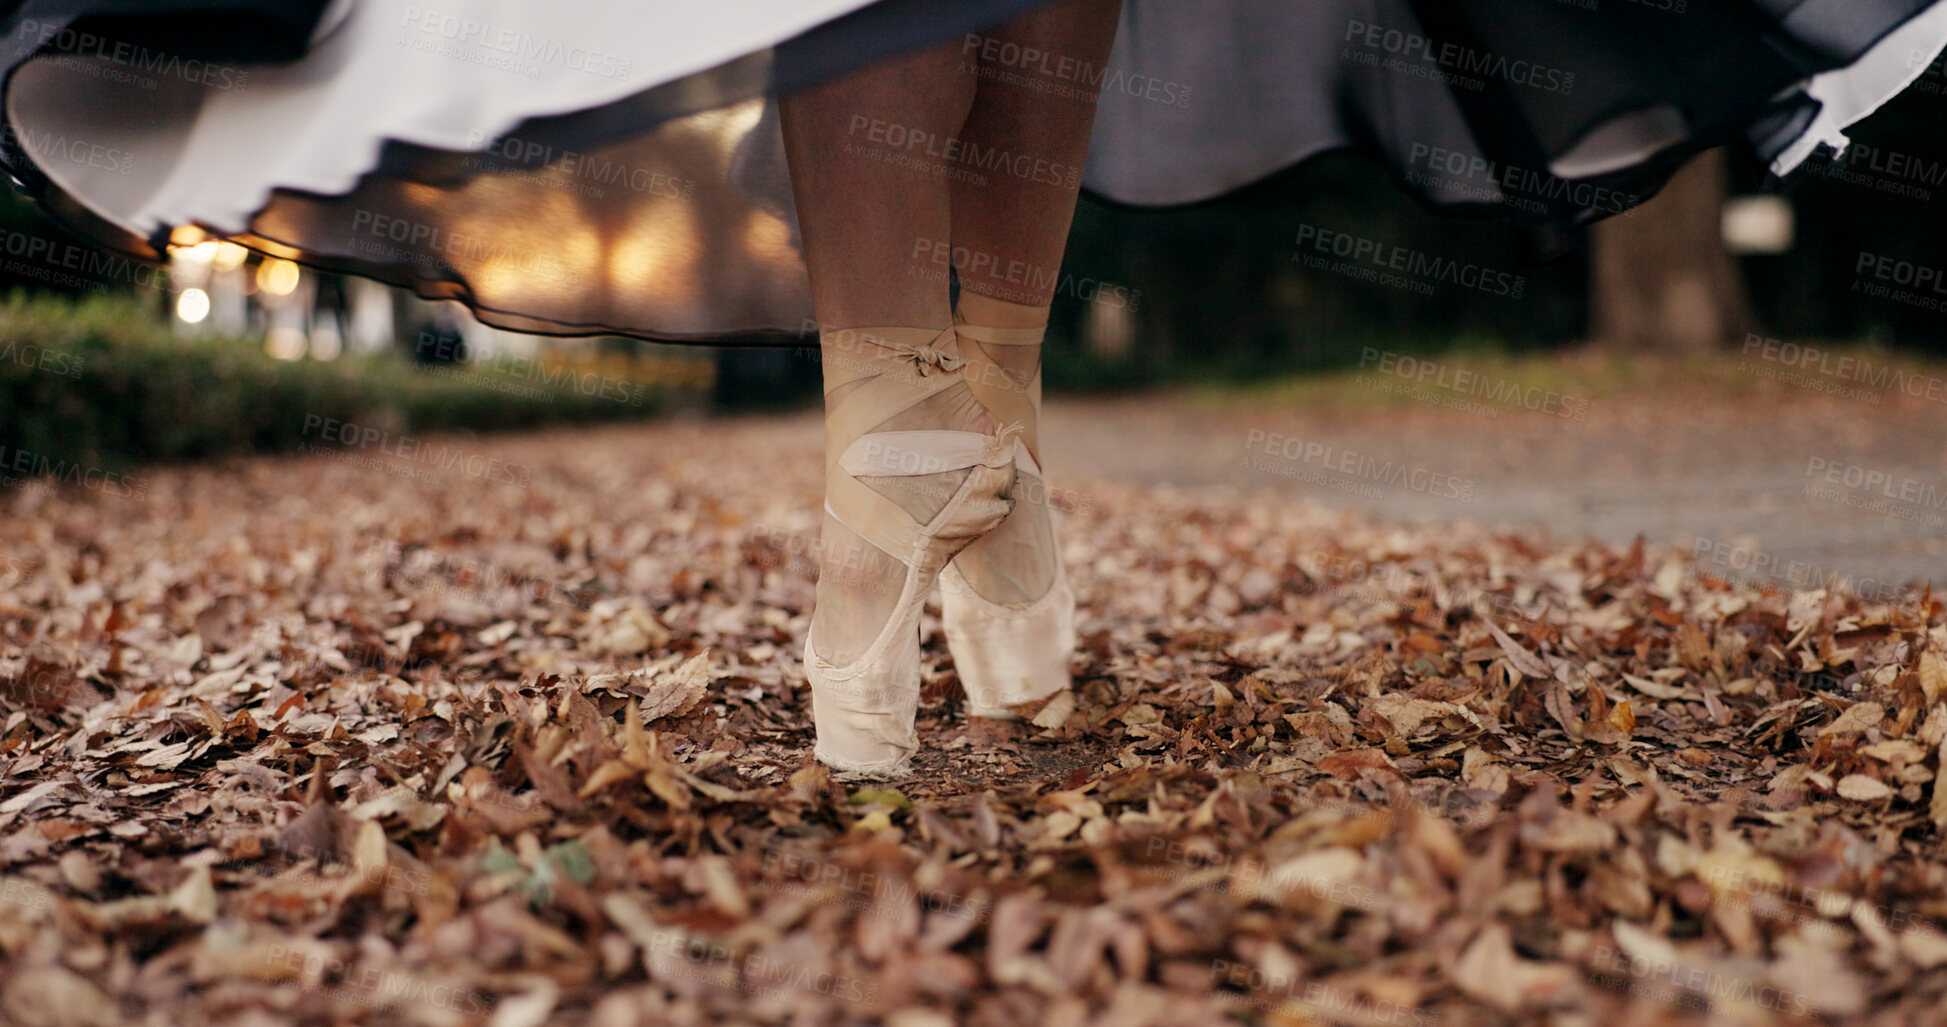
0 294 676 470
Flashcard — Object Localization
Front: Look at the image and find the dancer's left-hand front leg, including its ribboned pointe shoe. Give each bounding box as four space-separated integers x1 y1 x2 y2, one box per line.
781 45 1014 772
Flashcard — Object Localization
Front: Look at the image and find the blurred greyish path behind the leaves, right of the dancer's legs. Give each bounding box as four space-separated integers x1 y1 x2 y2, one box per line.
1044 388 1947 587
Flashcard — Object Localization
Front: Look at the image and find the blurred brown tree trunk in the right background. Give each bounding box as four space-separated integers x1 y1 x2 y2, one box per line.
1589 150 1754 353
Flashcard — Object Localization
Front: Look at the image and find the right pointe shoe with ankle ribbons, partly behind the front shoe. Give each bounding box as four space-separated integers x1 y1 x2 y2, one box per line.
940 290 1075 727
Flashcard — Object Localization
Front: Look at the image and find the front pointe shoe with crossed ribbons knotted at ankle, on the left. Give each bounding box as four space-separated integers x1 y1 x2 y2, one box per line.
804 327 1022 778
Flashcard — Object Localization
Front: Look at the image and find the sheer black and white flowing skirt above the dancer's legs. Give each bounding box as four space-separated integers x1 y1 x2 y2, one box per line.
0 0 1947 345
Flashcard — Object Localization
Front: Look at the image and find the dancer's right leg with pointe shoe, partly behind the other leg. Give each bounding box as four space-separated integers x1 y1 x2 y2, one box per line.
944 0 1121 715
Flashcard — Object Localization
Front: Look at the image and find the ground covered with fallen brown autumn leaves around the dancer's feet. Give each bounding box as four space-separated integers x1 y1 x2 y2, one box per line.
0 411 1947 1027
